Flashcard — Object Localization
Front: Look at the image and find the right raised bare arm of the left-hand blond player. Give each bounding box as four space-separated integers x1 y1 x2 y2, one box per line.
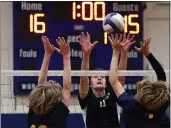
56 38 71 107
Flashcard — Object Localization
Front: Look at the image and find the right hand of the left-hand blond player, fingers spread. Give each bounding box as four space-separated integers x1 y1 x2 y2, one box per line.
55 37 70 57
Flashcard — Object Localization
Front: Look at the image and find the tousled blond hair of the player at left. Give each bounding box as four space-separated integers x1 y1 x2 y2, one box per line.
29 81 62 115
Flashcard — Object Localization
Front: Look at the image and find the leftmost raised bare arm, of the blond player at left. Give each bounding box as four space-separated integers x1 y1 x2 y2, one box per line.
38 36 55 84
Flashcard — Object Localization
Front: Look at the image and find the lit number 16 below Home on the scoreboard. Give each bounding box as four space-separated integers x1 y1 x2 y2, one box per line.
29 13 46 33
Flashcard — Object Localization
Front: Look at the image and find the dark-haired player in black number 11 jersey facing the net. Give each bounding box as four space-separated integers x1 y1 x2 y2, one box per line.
78 33 134 128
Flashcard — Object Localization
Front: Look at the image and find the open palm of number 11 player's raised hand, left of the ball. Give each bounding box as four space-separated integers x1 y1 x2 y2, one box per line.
79 32 98 54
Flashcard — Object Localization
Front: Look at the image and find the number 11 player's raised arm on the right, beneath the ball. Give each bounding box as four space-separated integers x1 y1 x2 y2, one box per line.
118 33 135 85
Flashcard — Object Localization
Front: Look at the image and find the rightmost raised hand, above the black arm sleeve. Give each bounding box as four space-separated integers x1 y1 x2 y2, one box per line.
134 37 151 56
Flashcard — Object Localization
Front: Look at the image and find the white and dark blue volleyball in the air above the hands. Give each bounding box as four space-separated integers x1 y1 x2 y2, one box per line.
103 13 124 34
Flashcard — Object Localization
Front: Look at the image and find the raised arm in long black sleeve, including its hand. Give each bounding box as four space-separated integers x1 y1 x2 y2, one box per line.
135 37 166 81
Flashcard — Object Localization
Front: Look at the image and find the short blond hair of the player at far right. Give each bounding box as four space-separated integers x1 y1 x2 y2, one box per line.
137 80 168 110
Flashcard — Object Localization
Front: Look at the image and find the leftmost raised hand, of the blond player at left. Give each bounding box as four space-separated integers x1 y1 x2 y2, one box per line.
42 36 55 55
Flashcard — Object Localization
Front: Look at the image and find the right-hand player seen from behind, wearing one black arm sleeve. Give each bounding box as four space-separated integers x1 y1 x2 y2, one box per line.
109 35 170 128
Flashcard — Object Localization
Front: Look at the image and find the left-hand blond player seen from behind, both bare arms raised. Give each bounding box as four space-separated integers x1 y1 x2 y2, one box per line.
28 37 71 128
